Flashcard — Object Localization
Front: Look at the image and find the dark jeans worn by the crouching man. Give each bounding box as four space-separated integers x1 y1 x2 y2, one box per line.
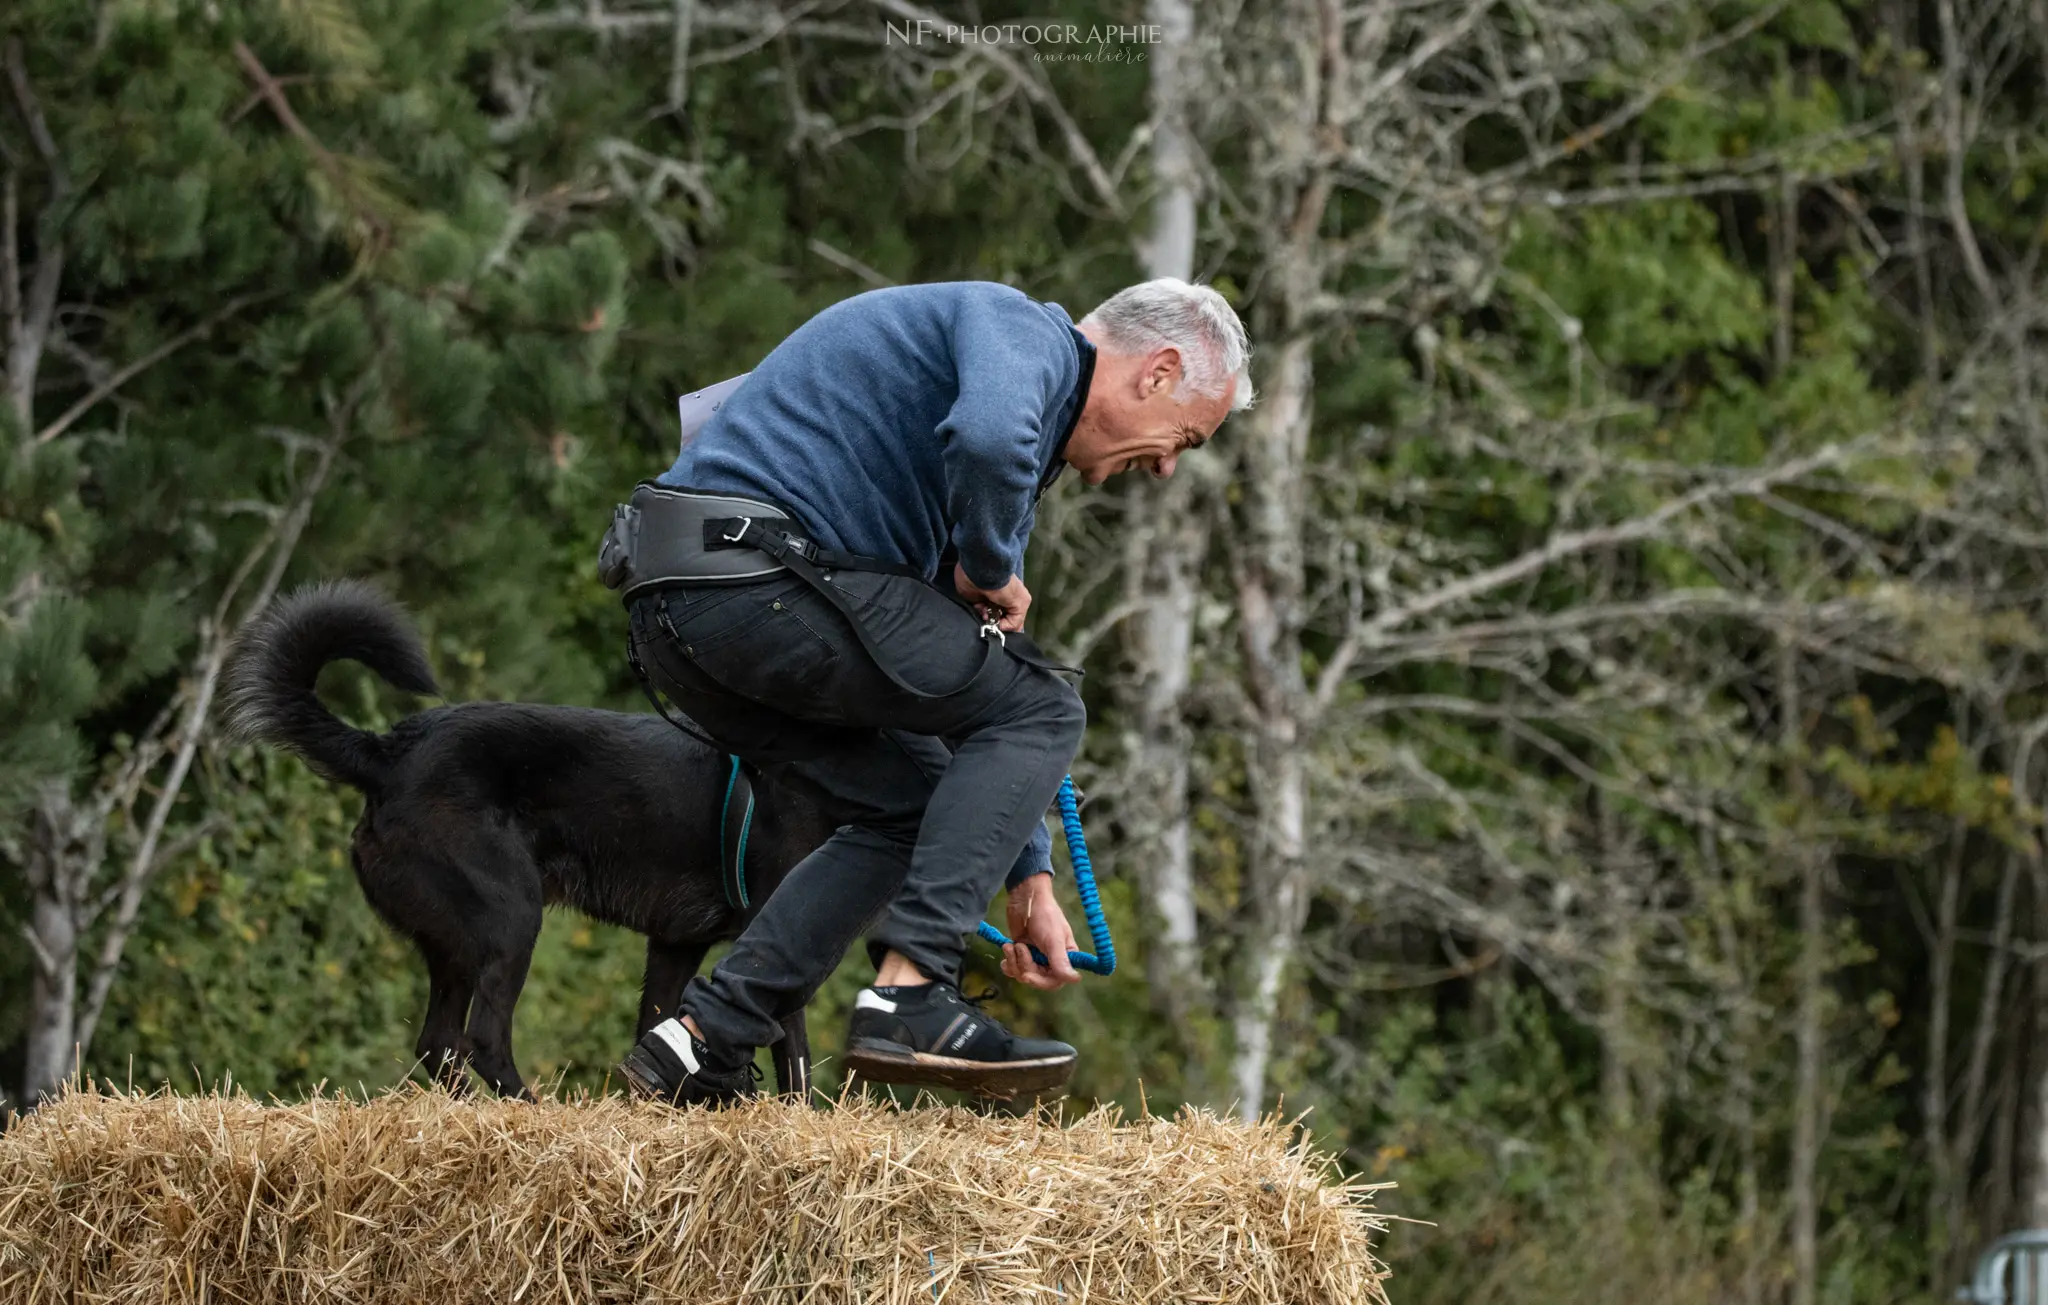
633 572 1085 1061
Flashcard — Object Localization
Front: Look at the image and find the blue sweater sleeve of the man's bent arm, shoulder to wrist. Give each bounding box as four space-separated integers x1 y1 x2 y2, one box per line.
938 293 1073 588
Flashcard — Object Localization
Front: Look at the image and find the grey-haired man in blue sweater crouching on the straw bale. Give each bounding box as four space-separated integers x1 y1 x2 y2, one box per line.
621 279 1251 1104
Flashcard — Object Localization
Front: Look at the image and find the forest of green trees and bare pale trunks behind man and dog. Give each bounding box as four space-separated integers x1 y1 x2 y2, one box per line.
0 0 2048 1305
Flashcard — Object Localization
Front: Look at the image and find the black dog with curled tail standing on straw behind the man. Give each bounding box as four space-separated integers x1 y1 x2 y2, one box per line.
227 582 831 1100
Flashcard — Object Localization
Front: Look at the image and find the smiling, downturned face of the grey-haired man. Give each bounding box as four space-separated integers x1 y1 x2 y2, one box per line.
1067 348 1237 486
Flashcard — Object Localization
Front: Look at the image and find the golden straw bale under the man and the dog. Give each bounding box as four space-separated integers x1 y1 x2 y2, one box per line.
0 1088 1384 1305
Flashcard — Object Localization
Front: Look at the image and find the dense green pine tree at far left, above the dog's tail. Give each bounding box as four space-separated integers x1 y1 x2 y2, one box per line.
0 0 625 1102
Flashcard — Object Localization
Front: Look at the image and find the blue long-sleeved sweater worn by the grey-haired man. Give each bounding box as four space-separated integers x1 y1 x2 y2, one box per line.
657 281 1096 887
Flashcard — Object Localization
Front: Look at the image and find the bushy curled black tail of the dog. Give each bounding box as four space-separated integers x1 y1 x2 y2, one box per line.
225 580 440 793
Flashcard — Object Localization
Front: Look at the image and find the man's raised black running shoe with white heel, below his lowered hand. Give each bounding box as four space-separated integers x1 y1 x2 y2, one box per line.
846 983 1075 1096
